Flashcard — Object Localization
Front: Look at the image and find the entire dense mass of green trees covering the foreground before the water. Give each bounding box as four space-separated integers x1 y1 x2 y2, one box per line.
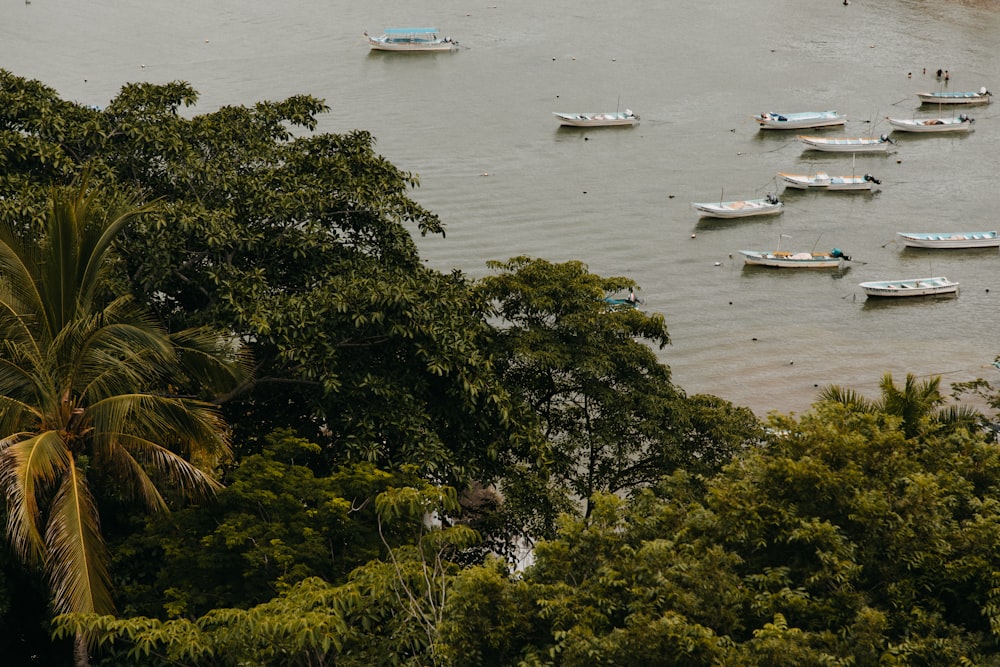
0 70 1000 667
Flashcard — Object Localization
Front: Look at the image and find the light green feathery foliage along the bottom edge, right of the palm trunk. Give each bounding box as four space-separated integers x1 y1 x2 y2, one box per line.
56 485 477 667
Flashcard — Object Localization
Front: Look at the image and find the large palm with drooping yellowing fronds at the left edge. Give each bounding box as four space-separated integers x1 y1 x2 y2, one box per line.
0 177 245 662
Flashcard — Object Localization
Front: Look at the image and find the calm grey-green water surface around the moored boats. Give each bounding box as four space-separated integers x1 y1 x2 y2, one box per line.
7 0 1000 414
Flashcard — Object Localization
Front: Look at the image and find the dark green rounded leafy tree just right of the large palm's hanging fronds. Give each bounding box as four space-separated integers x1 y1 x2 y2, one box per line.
113 431 438 619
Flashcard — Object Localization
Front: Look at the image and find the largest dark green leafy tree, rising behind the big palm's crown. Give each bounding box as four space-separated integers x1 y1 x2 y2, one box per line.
0 71 536 484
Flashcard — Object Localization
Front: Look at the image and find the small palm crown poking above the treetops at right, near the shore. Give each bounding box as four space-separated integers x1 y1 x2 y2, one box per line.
819 373 984 438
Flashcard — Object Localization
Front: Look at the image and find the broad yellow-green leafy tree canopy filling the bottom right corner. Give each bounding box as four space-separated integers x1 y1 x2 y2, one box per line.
441 402 1000 667
